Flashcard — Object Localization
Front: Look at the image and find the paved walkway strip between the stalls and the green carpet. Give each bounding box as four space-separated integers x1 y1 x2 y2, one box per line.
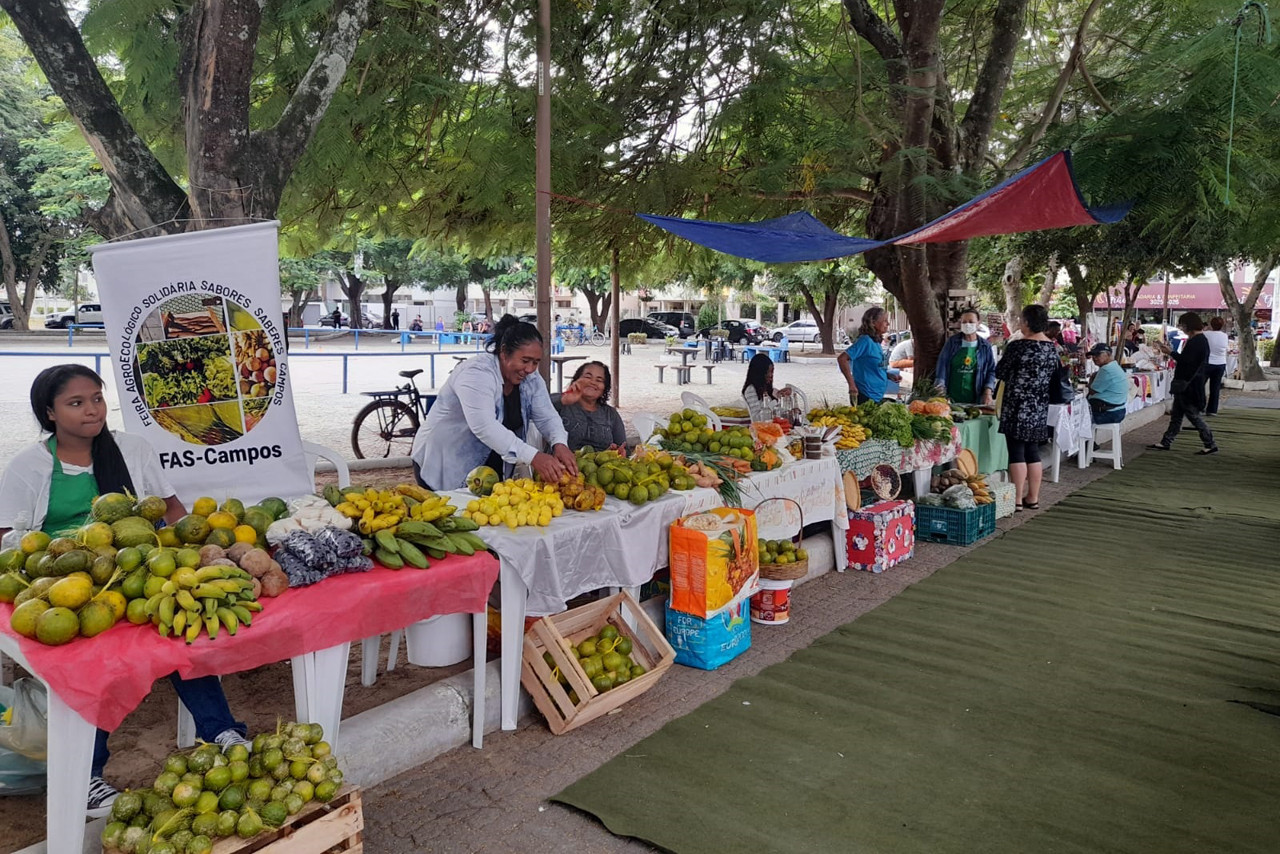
365 409 1198 854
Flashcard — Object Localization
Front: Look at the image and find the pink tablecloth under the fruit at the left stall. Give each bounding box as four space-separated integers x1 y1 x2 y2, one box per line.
0 552 498 730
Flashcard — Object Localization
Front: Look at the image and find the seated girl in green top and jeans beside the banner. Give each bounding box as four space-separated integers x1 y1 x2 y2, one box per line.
0 365 248 818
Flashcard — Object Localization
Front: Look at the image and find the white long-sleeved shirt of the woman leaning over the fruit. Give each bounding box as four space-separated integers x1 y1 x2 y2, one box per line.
410 353 568 489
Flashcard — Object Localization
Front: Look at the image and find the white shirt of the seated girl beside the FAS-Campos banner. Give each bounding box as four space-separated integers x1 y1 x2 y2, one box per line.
0 430 174 540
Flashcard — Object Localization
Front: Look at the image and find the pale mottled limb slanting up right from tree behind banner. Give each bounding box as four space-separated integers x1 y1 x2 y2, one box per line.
250 0 370 207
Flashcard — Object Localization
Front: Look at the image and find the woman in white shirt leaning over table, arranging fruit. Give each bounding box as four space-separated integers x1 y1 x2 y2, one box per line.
410 315 577 490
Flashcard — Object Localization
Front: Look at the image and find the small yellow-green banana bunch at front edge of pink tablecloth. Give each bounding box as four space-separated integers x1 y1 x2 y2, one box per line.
143 566 262 644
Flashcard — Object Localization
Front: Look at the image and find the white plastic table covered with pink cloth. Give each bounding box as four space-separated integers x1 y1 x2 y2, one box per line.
0 553 498 851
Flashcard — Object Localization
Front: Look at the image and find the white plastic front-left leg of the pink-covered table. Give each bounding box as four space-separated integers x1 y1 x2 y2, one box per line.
45 686 95 851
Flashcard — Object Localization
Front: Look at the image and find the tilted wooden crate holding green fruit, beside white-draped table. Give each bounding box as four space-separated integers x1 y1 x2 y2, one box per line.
520 590 676 735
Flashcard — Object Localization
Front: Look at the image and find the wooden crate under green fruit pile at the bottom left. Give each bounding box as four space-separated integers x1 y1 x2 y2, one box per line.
104 785 365 854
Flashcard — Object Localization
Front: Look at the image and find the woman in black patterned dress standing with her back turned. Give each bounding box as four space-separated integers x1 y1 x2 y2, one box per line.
996 305 1061 510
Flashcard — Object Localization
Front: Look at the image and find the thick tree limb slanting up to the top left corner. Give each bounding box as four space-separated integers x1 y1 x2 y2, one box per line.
0 0 187 237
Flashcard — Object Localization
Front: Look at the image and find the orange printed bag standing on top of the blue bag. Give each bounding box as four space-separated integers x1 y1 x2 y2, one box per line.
671 507 760 620
